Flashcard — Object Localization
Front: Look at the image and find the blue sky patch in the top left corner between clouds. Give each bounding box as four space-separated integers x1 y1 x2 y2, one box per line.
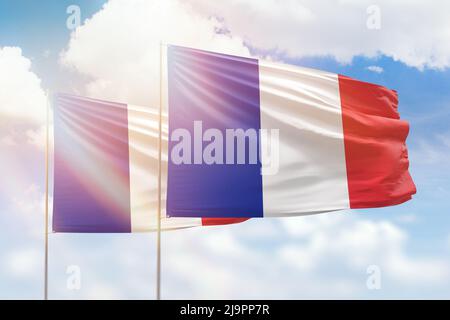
0 0 105 88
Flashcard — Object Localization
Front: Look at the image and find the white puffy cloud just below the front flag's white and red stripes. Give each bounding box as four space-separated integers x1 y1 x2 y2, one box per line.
282 214 450 285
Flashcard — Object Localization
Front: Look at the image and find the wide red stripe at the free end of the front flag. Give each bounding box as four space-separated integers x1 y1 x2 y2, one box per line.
339 75 416 208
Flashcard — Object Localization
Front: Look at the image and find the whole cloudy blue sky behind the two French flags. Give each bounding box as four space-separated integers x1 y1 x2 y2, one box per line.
0 0 450 299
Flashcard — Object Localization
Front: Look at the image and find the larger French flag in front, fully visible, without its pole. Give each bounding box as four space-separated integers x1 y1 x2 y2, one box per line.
166 46 416 218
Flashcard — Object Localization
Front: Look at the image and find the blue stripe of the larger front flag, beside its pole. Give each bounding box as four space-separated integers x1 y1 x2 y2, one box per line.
167 46 263 217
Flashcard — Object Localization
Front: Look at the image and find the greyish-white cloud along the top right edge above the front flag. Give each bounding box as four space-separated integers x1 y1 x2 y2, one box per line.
192 0 450 69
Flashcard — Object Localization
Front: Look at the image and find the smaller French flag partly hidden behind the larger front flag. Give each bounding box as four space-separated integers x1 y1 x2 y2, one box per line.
53 94 246 233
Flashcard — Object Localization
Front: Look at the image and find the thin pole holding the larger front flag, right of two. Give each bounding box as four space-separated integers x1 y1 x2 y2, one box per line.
156 42 163 300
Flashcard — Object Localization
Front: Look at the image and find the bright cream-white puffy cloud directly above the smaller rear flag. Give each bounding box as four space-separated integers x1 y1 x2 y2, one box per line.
61 0 249 105
